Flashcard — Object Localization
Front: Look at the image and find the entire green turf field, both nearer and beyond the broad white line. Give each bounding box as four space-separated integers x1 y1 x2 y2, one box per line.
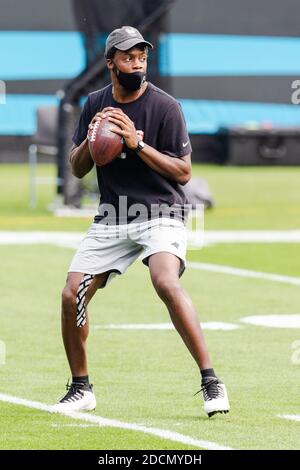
0 166 300 450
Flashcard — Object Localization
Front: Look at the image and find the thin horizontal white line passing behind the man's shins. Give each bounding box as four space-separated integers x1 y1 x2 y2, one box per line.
94 322 241 331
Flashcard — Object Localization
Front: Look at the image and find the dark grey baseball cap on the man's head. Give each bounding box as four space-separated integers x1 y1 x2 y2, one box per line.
104 26 153 59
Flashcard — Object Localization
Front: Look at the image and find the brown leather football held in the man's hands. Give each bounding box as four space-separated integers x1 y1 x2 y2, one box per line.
88 118 124 166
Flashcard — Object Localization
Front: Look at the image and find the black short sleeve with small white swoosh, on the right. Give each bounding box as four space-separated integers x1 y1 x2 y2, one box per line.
157 102 192 157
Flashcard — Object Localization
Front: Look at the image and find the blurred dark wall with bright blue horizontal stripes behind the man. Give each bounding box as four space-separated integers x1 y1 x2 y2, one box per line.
0 0 300 161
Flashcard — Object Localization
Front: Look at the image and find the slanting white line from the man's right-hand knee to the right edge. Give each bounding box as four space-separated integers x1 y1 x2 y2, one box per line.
187 261 300 286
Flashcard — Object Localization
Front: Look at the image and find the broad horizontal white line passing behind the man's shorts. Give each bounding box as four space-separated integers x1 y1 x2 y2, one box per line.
0 230 300 248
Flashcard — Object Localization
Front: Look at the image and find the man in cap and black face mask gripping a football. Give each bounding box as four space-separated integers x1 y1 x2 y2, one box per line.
53 26 229 416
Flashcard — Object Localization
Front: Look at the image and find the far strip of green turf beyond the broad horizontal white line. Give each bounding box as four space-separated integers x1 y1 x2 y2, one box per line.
0 165 300 230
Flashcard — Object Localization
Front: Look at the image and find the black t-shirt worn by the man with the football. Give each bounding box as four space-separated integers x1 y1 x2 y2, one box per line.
73 83 192 224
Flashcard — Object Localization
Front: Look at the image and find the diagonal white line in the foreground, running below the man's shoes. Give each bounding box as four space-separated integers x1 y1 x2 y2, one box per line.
0 393 233 450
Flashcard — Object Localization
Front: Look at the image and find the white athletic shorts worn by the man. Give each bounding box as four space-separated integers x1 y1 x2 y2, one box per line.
69 218 187 287
